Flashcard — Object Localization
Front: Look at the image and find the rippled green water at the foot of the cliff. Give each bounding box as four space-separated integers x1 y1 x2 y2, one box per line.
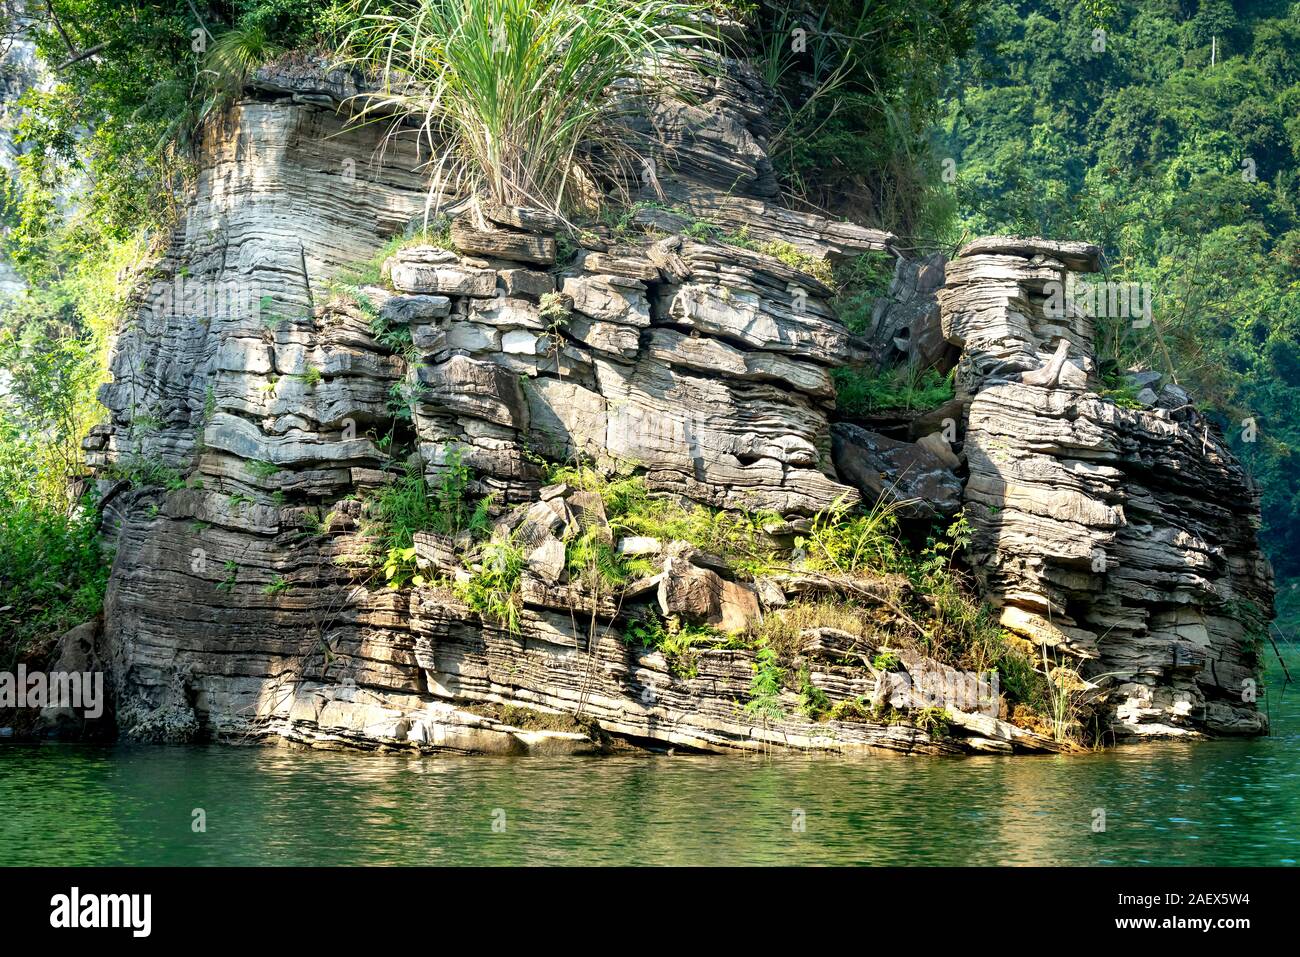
0 649 1300 865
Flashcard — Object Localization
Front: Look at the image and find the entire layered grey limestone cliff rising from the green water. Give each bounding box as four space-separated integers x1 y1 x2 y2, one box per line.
78 57 1269 753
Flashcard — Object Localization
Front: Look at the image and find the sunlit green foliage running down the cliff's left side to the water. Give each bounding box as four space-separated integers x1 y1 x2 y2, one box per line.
0 0 343 654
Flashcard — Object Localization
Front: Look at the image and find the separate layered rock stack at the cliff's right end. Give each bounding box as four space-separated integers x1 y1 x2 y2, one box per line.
940 238 1273 735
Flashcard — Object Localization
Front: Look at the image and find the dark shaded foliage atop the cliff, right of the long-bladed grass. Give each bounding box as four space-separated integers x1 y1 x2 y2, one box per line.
753 0 983 235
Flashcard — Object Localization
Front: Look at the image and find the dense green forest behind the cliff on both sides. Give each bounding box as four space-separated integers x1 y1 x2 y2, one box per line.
0 0 1300 665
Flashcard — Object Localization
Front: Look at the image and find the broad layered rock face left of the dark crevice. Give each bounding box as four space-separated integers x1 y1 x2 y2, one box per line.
87 72 915 750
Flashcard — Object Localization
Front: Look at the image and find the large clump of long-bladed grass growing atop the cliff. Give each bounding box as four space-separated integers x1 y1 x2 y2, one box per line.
342 0 707 213
